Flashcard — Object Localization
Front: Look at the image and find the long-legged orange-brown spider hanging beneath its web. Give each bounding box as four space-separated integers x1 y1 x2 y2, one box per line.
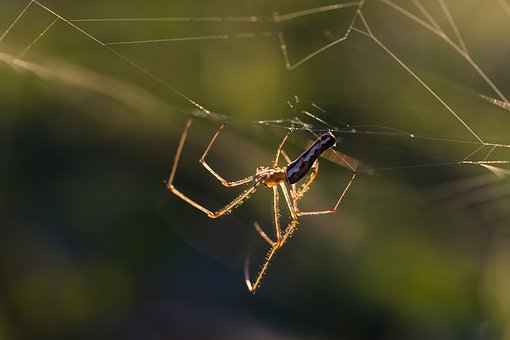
166 118 356 294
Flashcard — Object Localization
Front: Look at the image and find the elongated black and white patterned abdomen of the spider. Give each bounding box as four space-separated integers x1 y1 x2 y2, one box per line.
287 132 336 184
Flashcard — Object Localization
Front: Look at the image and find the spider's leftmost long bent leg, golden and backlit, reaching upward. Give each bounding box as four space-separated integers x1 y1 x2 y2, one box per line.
166 118 262 218
